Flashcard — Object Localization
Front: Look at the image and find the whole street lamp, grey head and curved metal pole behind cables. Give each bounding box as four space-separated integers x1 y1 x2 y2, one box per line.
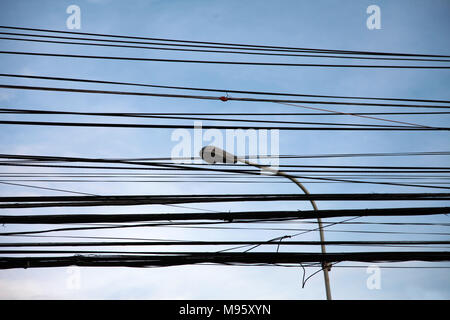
200 146 331 300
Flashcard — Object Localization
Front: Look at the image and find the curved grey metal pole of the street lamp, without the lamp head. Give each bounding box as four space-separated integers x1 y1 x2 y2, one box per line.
241 158 332 300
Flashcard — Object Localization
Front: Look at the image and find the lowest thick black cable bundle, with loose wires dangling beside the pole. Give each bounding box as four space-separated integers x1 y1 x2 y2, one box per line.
0 251 450 269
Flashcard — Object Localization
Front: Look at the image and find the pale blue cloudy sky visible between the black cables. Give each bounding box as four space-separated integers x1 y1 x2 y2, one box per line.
0 0 450 299
